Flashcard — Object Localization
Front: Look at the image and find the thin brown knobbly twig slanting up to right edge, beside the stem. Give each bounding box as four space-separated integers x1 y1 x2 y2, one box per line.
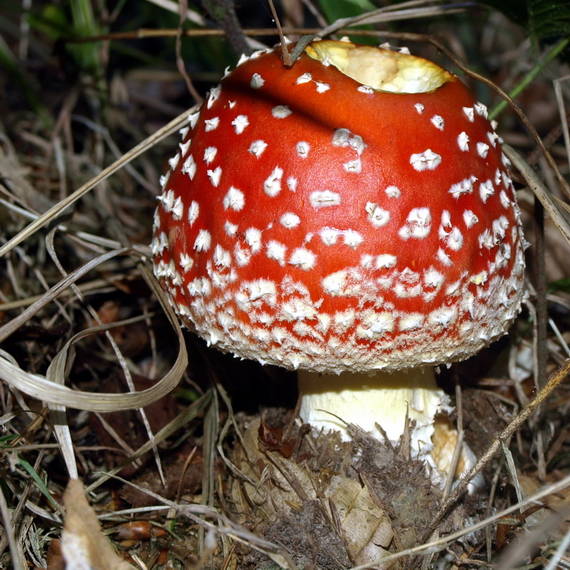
422 358 570 542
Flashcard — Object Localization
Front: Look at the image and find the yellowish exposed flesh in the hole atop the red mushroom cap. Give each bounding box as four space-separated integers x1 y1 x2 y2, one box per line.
305 40 453 93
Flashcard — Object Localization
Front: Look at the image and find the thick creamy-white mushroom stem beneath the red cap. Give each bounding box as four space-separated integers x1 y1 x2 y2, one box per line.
298 367 449 456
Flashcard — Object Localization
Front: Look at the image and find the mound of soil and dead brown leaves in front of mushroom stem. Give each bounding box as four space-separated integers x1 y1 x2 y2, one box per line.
228 411 458 570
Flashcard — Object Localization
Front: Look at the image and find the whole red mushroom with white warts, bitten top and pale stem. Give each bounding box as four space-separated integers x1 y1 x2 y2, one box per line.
152 41 524 472
